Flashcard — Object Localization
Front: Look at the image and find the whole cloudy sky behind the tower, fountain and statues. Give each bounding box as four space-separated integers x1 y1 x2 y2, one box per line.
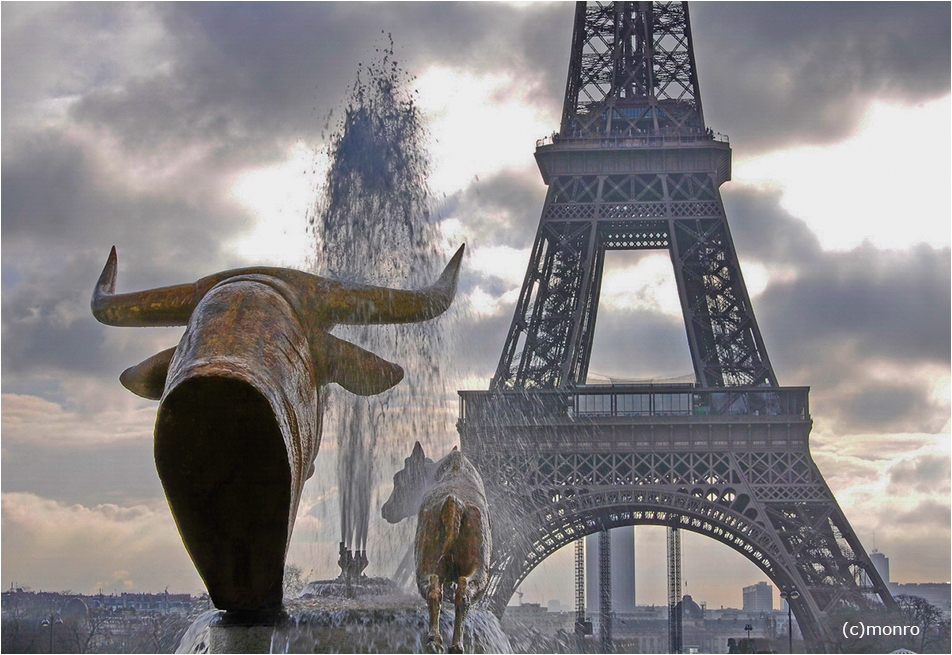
0 2 952 607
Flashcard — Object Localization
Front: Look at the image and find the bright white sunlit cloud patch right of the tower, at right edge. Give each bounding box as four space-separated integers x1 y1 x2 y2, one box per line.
733 96 952 250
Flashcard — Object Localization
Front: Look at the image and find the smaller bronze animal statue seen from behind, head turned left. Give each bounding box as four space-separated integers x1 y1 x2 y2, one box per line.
381 441 492 653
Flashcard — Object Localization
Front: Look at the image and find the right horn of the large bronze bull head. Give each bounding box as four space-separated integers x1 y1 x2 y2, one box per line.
325 244 466 325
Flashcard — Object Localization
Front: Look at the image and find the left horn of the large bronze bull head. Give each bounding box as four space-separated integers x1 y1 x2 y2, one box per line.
90 246 200 327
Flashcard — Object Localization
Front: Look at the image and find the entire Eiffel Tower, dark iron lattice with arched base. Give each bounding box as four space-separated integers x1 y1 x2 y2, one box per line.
458 2 896 651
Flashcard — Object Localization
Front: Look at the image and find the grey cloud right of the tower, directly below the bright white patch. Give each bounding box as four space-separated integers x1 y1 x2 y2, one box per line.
724 187 952 368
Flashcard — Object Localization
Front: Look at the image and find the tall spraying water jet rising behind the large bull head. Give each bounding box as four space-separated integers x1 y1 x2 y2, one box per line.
310 43 453 574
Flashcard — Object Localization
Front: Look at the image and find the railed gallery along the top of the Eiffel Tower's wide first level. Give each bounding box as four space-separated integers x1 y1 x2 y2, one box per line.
459 385 810 425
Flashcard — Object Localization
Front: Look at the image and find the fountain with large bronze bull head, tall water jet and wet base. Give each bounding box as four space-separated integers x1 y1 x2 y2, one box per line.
92 43 509 652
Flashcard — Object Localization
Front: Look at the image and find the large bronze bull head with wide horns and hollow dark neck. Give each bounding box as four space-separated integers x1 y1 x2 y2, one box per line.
92 247 463 610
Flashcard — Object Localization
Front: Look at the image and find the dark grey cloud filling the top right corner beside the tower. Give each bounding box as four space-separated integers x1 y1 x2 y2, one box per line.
691 2 950 154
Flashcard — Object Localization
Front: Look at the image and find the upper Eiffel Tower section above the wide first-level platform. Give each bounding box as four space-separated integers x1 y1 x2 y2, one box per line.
492 2 777 389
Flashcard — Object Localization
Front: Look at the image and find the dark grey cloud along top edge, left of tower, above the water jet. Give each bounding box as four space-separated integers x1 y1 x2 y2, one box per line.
74 3 571 158
